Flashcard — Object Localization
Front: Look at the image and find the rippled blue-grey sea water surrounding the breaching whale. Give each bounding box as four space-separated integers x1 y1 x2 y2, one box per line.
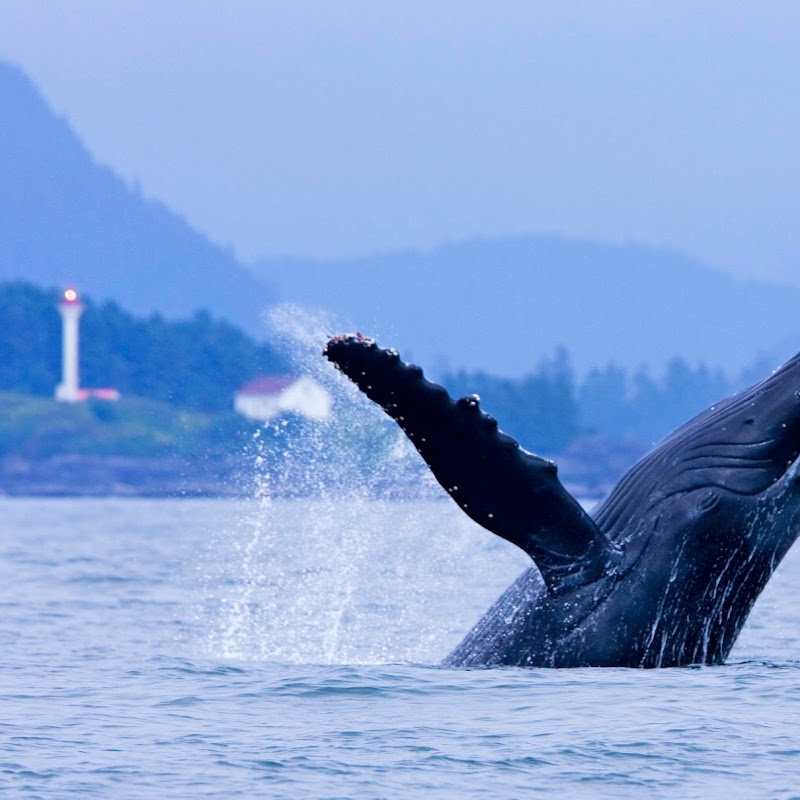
0 499 800 798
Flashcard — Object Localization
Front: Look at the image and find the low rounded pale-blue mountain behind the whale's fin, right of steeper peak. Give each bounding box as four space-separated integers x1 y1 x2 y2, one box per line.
253 236 800 376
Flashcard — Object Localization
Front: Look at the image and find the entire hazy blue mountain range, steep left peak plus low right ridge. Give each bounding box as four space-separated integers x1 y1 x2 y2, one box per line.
0 57 800 377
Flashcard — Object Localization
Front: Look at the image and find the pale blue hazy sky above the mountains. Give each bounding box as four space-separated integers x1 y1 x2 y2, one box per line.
0 0 800 285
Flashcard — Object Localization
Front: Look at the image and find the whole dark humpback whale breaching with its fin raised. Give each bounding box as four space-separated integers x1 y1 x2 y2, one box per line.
324 334 800 667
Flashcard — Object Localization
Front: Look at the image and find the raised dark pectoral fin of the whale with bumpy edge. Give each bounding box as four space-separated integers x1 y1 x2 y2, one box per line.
324 334 619 593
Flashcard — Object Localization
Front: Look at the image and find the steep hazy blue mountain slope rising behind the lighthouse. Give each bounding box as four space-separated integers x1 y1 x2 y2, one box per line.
0 62 270 332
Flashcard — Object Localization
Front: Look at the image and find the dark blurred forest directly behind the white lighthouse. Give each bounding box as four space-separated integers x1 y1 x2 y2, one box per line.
0 282 288 412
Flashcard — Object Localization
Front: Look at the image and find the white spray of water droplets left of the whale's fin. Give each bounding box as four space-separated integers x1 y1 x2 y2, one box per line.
200 308 525 664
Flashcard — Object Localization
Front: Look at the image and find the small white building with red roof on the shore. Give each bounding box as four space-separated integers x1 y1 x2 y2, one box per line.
233 375 331 422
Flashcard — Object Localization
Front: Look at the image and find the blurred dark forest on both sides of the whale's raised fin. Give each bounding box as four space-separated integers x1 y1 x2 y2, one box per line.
0 282 771 454
